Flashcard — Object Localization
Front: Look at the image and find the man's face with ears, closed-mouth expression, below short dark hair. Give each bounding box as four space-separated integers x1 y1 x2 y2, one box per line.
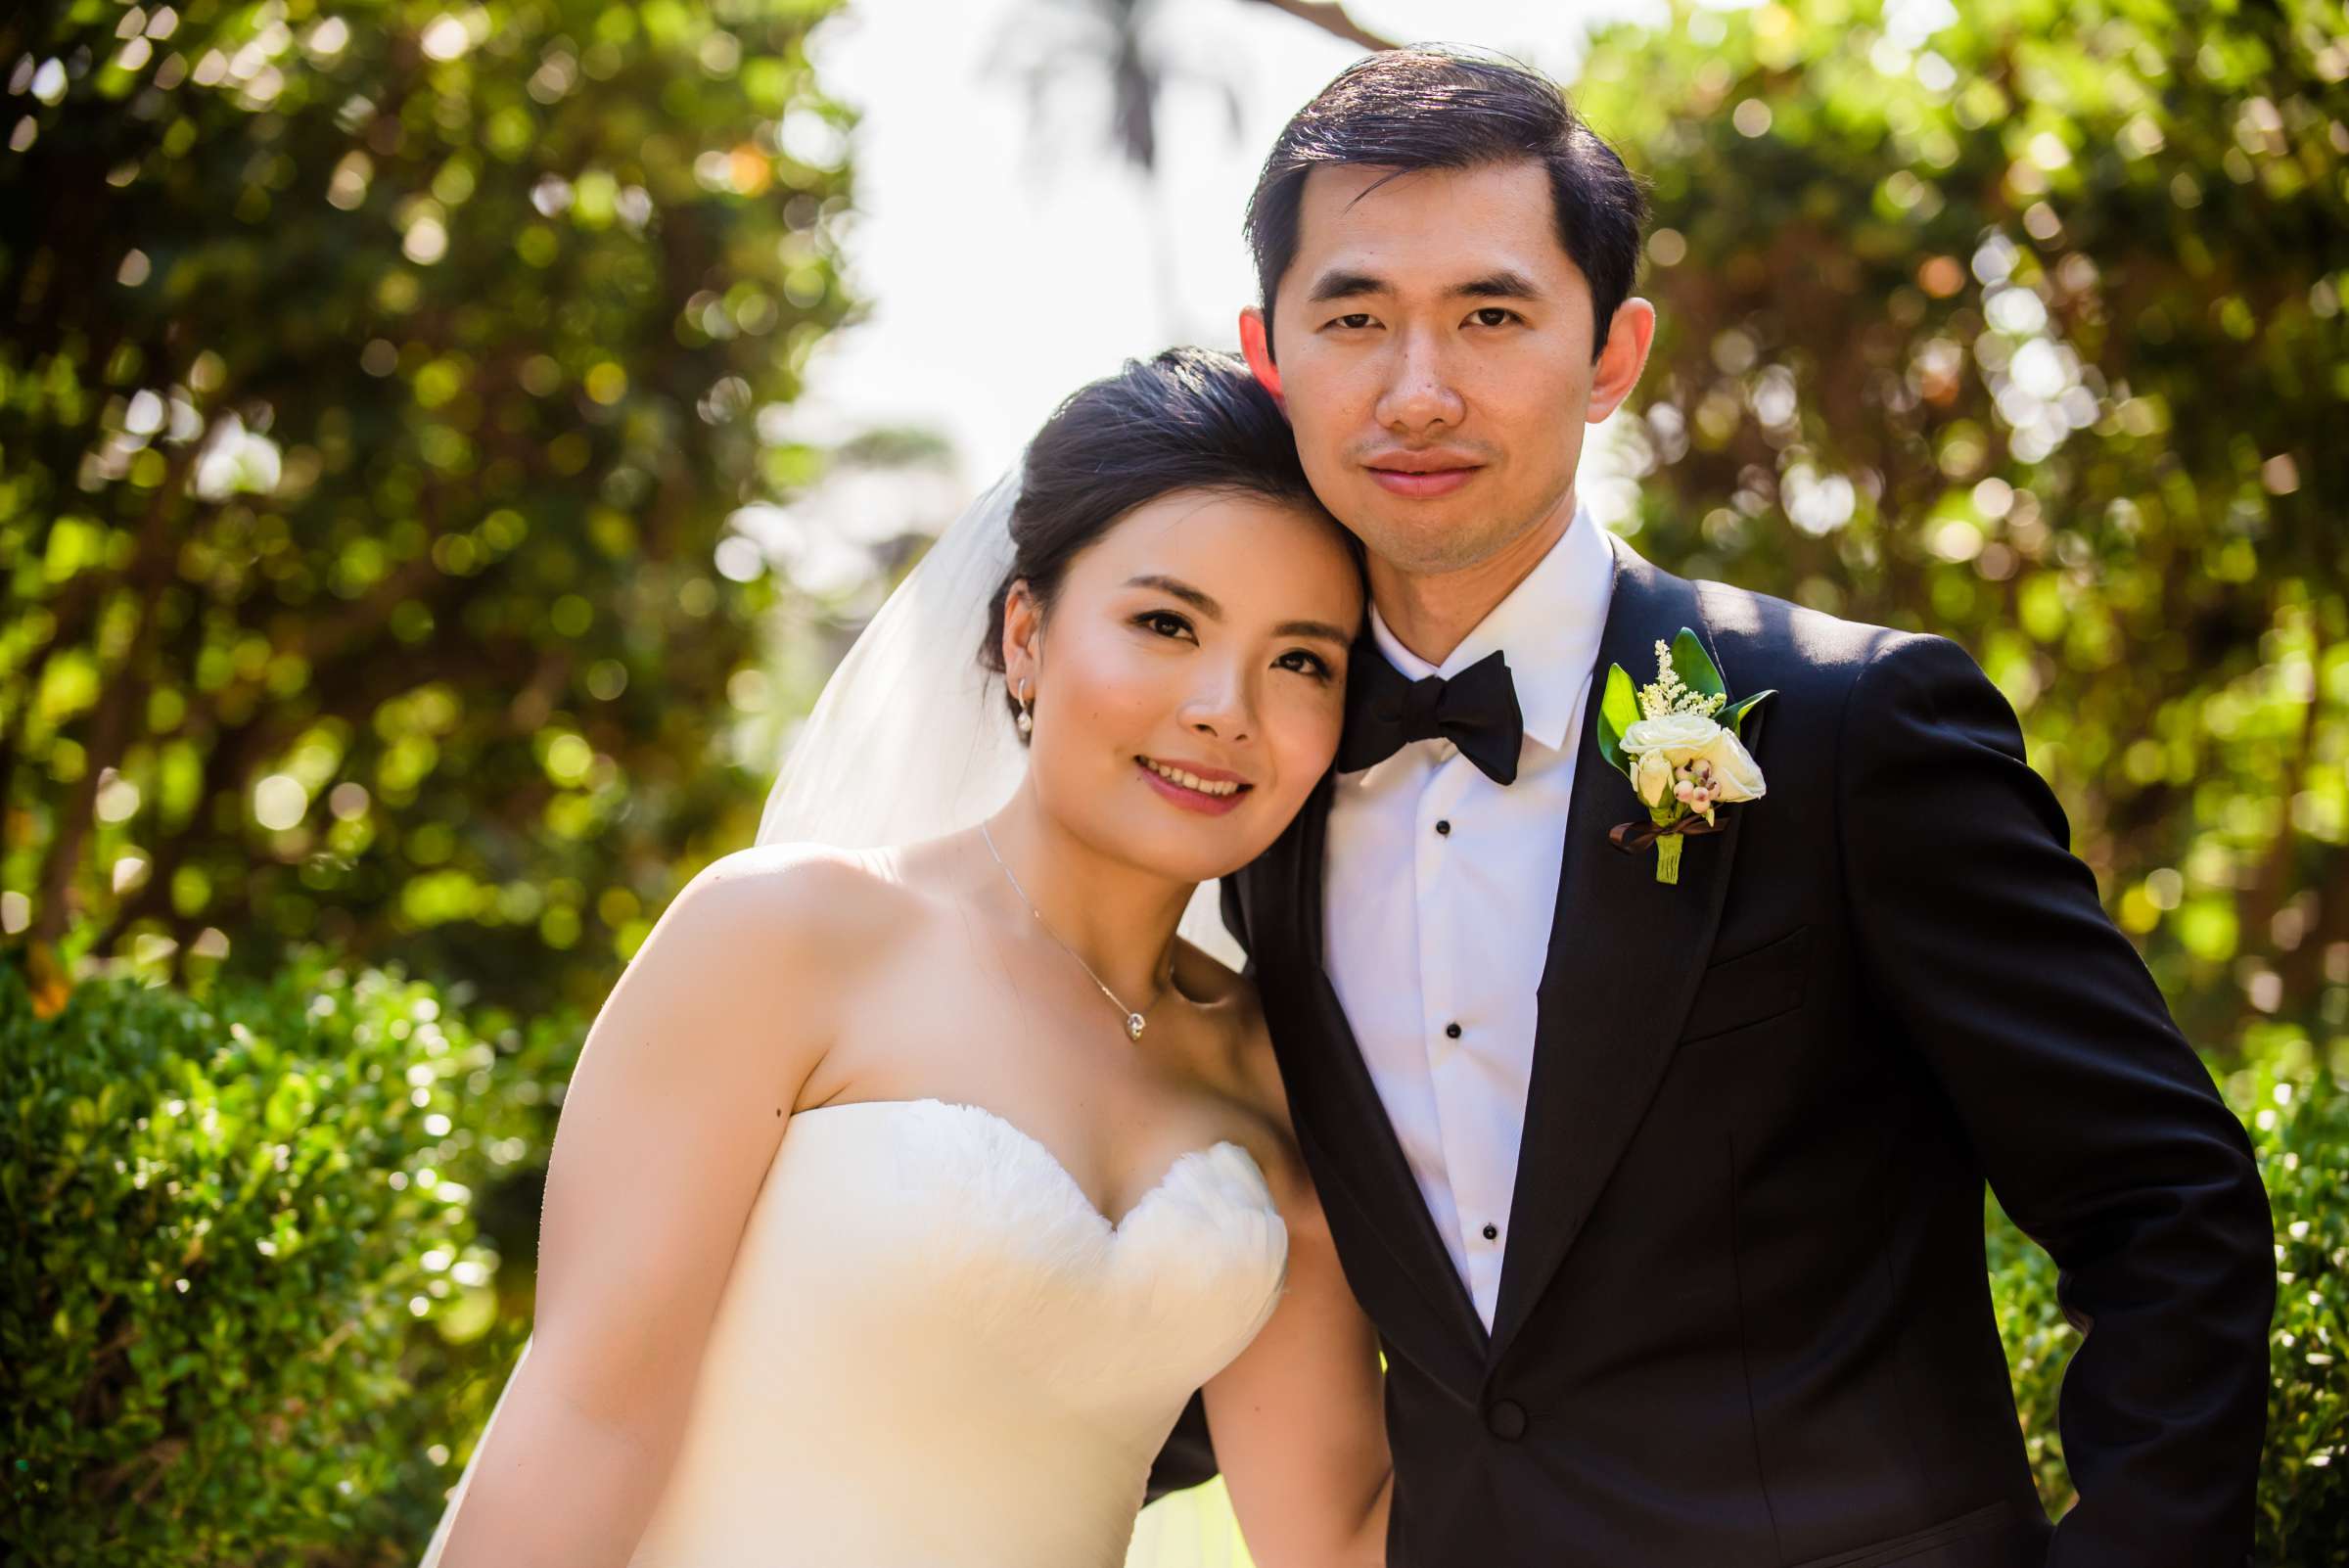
1243 161 1654 576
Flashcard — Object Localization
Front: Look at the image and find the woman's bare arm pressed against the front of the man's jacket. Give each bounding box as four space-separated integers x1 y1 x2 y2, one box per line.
1205 1009 1393 1568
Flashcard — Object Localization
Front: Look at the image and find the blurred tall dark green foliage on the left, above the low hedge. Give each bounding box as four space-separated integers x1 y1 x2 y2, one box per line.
0 0 851 1018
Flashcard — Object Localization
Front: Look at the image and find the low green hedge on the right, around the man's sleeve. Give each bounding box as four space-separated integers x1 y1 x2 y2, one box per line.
1990 1038 2349 1568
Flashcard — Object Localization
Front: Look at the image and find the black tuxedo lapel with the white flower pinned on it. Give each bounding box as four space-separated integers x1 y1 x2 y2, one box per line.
1487 535 1760 1368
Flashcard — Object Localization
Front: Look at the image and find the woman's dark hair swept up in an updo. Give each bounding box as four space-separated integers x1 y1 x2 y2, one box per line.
980 347 1360 737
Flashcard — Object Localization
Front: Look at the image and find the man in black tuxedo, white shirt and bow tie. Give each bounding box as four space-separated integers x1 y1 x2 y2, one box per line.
1156 52 2274 1568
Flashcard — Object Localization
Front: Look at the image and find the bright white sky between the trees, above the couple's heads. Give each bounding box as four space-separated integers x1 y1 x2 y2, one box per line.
797 0 1656 492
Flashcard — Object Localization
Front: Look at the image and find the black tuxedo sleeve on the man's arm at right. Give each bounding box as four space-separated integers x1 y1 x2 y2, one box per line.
1834 636 2277 1568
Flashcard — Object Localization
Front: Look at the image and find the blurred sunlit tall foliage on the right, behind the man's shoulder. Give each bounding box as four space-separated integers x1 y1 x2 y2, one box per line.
1576 0 2349 1051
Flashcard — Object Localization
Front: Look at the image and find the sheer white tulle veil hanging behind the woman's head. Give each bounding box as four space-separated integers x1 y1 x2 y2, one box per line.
759 462 1243 967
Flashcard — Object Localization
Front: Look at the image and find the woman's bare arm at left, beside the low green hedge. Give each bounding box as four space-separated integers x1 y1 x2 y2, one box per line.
441 850 862 1568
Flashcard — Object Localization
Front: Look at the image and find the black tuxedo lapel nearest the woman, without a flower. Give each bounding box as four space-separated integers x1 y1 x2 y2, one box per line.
1250 774 1485 1370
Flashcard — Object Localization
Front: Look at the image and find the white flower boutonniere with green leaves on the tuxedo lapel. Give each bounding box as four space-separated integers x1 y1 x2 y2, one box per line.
1599 626 1775 883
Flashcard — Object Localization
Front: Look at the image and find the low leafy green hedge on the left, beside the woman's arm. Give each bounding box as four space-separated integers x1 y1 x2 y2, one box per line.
0 955 576 1568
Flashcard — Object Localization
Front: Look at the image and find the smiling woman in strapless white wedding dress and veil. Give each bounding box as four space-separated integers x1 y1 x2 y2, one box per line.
425 349 1388 1568
